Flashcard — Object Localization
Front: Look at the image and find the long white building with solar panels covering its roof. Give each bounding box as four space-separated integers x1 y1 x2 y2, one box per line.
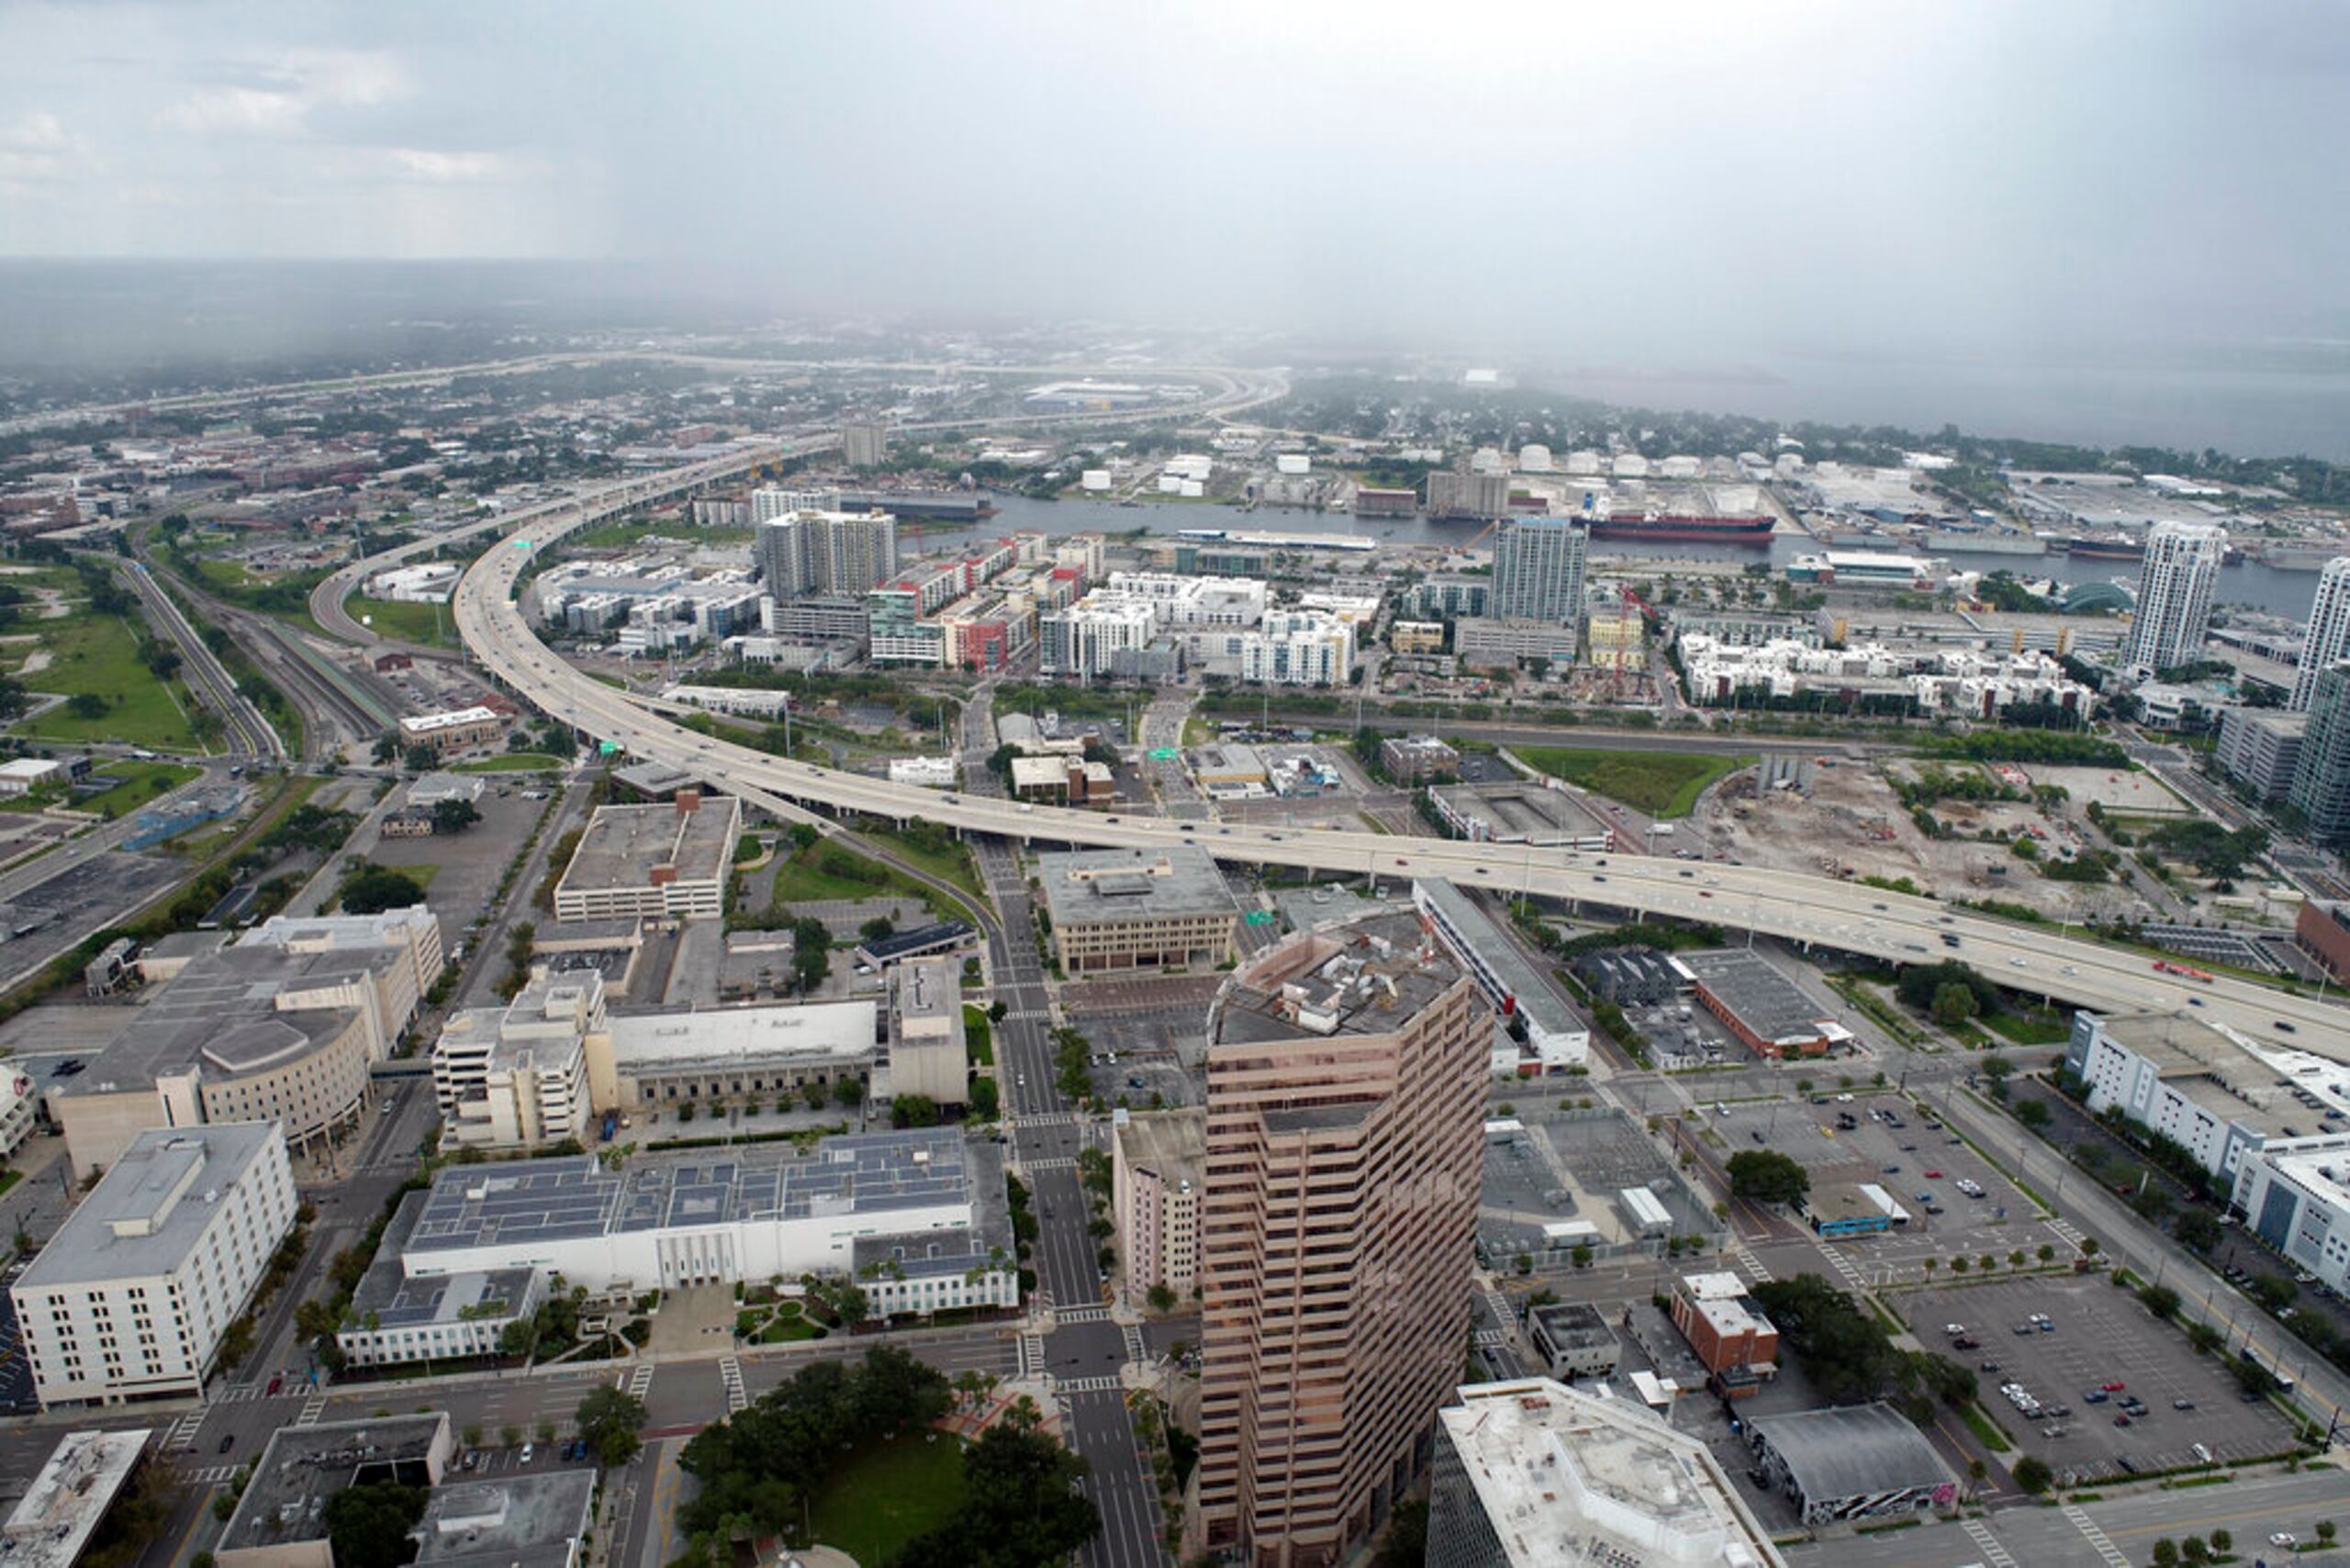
357 1128 1020 1326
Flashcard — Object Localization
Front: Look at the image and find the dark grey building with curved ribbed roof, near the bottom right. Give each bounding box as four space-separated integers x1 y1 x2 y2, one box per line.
1746 1401 1957 1526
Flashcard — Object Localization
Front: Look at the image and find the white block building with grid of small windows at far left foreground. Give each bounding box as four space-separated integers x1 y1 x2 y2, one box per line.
9 1121 297 1408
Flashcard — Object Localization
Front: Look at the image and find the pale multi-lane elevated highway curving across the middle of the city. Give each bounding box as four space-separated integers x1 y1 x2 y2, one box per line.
456 506 2350 1060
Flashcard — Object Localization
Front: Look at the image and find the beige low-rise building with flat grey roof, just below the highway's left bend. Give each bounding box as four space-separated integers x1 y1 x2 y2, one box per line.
554 790 743 922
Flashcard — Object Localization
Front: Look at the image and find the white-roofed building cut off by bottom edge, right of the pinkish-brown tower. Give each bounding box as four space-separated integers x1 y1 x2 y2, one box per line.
1427 1378 1786 1568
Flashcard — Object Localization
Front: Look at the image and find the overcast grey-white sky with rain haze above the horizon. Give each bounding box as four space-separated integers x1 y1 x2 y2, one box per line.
0 0 2350 362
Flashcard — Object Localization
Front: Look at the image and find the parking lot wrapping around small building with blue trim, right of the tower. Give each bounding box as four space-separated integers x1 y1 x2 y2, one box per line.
1707 1091 2073 1279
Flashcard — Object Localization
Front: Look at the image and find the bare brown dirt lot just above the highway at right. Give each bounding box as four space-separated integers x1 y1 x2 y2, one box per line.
1696 764 2153 919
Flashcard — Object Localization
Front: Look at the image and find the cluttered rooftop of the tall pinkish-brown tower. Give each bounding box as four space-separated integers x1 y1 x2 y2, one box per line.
1208 914 1461 1044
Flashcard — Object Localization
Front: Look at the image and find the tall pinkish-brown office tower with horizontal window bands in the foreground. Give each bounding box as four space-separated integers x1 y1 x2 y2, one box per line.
1189 914 1493 1568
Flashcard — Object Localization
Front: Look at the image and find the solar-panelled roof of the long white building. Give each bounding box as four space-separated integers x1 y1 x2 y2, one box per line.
404 1128 994 1255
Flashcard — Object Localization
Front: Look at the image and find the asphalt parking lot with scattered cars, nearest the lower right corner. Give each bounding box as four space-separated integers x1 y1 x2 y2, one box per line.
1892 1274 2291 1479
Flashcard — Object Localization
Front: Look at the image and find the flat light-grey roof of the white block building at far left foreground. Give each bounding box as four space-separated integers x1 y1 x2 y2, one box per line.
17 1121 285 1288
